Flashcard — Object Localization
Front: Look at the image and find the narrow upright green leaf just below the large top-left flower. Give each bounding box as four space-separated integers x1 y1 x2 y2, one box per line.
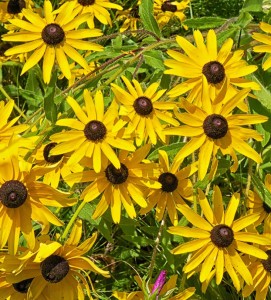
44 73 57 123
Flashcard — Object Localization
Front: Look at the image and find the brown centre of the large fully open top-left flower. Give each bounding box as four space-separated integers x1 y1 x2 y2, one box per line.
41 23 65 46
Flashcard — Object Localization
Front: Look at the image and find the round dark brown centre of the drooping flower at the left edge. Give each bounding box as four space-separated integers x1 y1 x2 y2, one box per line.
0 180 27 208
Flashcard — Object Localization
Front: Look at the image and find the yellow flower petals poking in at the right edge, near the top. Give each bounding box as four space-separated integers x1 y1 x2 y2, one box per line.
252 22 271 70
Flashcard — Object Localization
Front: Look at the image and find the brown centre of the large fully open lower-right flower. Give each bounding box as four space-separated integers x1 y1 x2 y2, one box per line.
211 224 234 248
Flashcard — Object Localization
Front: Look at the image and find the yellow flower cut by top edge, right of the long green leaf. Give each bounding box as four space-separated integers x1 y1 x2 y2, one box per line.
153 0 190 27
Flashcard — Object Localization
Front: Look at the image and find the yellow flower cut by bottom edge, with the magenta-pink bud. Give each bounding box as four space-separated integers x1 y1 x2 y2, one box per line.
113 270 196 300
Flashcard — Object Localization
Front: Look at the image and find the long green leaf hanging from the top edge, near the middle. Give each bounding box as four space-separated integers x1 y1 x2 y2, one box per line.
139 0 161 37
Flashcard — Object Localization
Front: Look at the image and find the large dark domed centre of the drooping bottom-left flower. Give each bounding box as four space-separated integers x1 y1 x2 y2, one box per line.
40 255 70 283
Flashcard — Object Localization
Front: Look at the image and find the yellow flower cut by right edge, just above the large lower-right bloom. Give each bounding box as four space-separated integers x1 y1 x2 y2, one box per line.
246 174 271 226
